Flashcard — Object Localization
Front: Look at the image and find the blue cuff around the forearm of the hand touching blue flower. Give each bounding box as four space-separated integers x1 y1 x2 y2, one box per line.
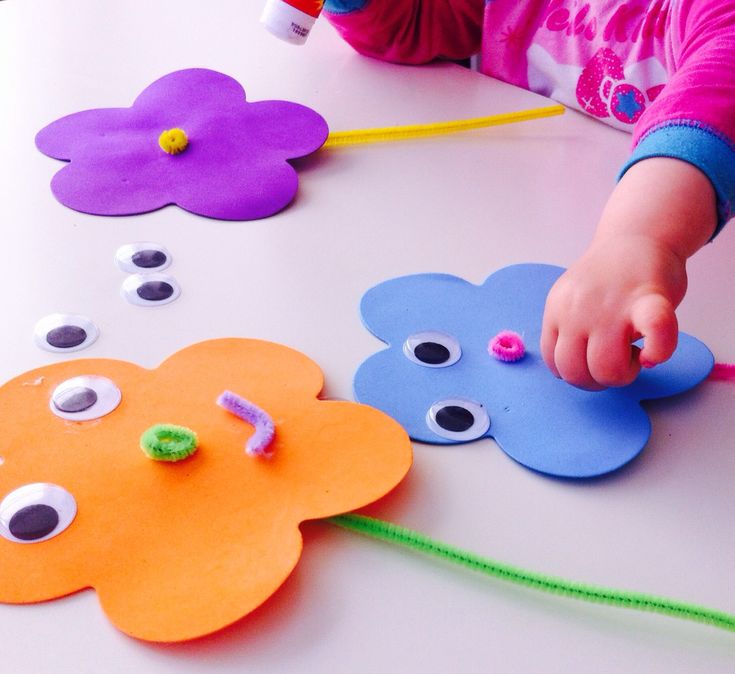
618 121 735 237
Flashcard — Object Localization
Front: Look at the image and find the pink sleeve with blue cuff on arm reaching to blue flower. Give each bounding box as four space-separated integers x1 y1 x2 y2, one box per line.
620 0 735 234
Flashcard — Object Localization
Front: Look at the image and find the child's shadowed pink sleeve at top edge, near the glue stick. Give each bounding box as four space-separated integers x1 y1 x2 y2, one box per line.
324 0 485 64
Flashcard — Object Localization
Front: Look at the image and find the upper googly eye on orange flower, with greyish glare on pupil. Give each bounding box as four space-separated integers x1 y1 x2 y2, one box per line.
49 375 122 421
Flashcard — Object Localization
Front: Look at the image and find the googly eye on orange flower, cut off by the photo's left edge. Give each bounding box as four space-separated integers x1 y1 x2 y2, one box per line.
0 482 77 543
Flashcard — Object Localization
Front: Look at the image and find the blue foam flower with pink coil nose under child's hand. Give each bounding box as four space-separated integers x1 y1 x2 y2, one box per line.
354 264 714 478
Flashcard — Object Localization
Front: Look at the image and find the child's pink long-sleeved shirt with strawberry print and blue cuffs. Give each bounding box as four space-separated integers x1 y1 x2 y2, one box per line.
325 0 735 226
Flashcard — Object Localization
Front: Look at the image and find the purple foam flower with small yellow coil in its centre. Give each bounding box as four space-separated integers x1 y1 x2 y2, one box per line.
36 68 329 220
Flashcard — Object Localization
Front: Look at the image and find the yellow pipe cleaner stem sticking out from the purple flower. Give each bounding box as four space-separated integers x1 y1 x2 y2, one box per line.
324 105 565 147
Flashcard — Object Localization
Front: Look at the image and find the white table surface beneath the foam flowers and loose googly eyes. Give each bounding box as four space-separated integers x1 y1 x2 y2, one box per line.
0 0 735 674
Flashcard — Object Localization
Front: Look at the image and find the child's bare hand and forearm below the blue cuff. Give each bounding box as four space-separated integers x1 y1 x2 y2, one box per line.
541 157 716 389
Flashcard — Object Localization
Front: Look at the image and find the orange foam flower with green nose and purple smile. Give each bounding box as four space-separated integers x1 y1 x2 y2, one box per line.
0 339 411 642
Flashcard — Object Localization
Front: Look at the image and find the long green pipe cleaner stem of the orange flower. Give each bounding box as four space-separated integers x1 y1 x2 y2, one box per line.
327 513 735 632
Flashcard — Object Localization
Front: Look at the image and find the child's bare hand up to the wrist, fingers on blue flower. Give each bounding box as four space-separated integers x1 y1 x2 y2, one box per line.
541 234 686 389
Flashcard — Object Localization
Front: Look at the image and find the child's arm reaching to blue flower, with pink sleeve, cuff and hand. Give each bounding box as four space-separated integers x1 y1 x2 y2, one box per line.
541 0 735 388
